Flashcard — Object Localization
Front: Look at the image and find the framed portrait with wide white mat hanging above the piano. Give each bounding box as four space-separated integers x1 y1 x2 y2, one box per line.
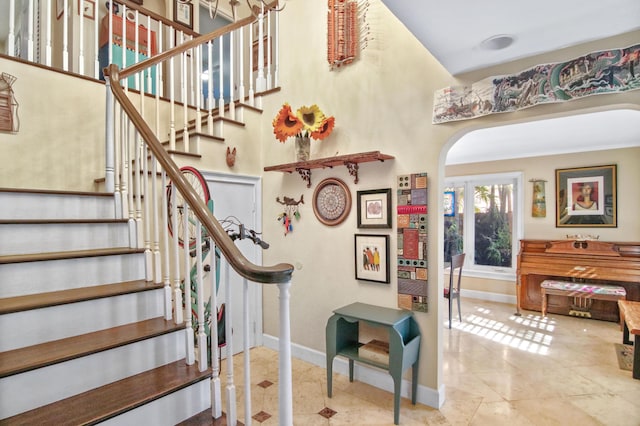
556 164 618 228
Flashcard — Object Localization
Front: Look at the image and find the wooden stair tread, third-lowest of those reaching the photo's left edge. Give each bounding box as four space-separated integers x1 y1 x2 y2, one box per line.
0 280 163 314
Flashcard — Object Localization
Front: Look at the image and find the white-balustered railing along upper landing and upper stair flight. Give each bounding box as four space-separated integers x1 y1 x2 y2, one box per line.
0 0 278 109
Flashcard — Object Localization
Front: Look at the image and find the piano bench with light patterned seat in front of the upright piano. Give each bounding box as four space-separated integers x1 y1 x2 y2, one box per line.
540 280 627 318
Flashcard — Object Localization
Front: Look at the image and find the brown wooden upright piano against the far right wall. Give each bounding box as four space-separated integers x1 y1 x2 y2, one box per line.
517 239 640 321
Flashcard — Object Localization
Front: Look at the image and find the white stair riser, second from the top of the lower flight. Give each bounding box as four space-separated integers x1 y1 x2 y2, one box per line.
0 222 129 256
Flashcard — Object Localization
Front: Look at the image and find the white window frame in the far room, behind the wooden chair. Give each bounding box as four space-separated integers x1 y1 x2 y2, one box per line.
444 172 524 280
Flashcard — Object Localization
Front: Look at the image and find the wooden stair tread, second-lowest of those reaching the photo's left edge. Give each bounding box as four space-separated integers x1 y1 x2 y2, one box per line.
0 317 184 377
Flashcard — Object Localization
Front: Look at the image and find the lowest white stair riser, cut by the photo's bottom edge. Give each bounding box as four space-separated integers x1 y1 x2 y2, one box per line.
100 380 211 426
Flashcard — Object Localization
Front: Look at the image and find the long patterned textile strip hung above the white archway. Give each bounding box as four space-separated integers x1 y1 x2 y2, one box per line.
432 44 640 124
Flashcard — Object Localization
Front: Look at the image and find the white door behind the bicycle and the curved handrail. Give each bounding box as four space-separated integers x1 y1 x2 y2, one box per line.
201 171 263 355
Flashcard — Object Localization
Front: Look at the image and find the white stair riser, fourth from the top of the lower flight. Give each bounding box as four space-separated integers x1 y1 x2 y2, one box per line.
0 289 164 351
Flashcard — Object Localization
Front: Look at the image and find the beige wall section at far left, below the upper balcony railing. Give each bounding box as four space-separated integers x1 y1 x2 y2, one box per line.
0 62 105 191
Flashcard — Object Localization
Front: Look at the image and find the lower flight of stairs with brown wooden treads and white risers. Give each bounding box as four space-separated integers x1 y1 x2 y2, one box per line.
0 189 211 425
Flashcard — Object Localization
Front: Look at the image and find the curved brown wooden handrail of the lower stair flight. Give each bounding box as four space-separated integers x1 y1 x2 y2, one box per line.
106 64 293 284
